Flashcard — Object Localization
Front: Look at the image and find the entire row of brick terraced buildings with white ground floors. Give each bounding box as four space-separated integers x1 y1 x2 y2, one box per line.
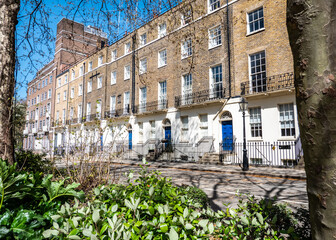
24 0 299 165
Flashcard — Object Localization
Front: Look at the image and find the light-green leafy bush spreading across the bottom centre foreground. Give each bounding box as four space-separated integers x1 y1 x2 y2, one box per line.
43 164 309 240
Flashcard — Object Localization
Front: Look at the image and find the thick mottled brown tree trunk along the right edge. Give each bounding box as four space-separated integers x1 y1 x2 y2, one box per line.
287 0 336 240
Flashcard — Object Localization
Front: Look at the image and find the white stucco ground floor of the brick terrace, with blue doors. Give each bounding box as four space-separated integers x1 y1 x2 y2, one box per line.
53 92 300 165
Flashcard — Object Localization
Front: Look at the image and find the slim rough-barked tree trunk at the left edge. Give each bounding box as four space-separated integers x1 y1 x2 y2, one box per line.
0 0 20 164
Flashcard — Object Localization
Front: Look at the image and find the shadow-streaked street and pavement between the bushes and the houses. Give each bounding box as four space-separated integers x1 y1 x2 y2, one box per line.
110 160 308 209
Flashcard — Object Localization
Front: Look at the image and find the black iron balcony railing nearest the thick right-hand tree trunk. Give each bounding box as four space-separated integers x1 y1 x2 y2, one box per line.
240 72 294 95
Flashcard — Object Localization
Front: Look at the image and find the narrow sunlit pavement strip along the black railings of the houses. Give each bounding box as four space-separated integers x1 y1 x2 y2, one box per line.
109 159 306 180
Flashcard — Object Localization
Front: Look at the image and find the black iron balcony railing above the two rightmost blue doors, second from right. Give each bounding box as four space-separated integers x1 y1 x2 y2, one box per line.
175 84 226 107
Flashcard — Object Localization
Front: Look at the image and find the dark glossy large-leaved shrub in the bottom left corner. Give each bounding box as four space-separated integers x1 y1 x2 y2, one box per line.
0 160 84 239
